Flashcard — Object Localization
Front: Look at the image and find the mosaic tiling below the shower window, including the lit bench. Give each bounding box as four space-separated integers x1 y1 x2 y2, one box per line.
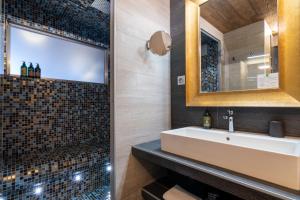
0 76 110 199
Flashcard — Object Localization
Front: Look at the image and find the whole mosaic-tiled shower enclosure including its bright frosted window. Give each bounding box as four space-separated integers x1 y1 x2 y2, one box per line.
0 0 111 200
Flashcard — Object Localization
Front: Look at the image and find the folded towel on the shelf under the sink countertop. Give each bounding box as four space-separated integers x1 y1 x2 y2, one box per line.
163 185 201 200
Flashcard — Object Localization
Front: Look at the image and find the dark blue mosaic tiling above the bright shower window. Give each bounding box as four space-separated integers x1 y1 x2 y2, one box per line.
3 0 110 47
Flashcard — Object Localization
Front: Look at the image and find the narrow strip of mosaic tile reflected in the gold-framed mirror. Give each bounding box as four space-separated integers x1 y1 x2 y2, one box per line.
201 33 219 92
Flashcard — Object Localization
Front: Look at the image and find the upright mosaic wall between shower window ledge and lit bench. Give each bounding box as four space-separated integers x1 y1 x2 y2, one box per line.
1 76 109 158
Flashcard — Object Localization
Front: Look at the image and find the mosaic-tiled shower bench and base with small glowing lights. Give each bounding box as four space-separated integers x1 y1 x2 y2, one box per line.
0 140 110 200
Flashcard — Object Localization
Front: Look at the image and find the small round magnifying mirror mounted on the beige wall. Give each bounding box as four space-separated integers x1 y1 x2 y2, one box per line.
147 31 172 56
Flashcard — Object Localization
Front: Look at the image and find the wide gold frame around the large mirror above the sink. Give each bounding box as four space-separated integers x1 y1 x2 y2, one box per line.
185 0 300 107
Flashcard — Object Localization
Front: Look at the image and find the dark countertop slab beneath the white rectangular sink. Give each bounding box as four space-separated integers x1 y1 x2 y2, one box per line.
132 140 300 200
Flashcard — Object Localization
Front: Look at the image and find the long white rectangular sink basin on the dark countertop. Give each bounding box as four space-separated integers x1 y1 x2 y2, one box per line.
161 127 300 191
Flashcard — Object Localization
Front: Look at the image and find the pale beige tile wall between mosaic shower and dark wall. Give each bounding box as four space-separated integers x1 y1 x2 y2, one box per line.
114 0 170 200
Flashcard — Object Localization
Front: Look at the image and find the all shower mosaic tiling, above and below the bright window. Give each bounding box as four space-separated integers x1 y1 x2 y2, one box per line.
0 0 110 199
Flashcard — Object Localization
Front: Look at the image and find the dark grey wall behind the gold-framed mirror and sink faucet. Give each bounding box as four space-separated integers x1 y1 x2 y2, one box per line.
171 0 300 137
